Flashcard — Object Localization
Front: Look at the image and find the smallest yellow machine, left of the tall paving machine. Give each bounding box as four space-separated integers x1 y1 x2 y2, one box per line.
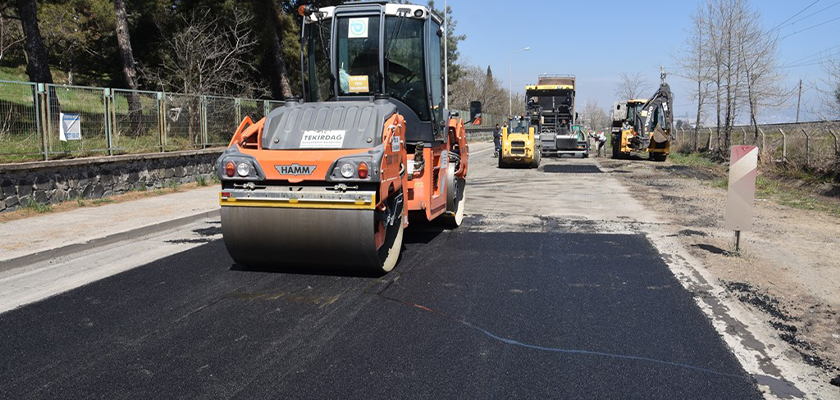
499 117 542 168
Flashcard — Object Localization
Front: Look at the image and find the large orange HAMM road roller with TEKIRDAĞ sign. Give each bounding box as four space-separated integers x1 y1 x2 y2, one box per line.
217 1 472 273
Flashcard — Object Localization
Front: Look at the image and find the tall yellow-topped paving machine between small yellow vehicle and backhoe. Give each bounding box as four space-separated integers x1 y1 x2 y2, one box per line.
525 74 588 156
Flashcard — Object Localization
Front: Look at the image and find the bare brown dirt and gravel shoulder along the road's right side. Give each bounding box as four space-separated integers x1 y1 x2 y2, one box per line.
599 158 840 380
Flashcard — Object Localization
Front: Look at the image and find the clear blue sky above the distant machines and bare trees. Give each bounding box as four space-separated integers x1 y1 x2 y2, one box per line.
450 0 840 122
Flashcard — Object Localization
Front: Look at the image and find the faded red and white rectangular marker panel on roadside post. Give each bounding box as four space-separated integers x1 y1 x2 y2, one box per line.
725 146 758 231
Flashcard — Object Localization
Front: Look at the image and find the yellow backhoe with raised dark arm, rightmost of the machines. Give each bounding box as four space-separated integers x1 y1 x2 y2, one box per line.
610 70 674 161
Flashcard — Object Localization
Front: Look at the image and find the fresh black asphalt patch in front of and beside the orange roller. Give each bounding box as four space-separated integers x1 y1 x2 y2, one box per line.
0 220 760 399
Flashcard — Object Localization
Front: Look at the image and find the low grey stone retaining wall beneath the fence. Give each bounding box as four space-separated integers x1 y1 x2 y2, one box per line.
0 149 222 212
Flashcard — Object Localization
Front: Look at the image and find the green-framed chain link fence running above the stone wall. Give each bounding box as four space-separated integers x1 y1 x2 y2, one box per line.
0 80 283 163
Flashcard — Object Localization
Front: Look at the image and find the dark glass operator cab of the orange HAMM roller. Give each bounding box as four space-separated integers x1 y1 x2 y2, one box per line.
301 1 449 143
